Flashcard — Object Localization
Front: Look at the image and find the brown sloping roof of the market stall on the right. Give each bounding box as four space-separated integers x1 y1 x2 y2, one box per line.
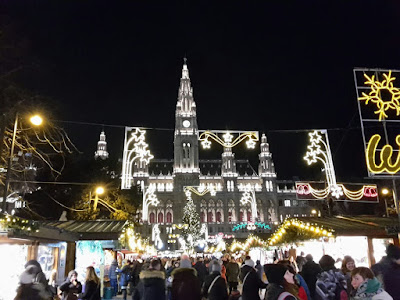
297 216 399 237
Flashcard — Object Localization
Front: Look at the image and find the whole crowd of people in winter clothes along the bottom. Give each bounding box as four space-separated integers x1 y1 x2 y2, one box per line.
15 244 400 300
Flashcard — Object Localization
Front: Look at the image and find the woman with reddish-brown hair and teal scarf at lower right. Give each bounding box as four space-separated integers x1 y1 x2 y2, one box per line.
351 267 393 300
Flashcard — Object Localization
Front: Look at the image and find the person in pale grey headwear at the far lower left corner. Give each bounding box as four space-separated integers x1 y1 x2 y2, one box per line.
14 264 51 300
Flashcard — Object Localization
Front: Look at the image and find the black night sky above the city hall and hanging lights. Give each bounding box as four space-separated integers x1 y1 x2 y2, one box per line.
0 0 400 181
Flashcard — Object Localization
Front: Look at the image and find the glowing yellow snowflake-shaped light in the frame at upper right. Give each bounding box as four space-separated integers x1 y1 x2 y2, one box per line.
358 71 400 121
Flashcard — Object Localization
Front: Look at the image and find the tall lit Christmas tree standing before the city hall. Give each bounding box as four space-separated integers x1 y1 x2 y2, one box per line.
183 197 200 249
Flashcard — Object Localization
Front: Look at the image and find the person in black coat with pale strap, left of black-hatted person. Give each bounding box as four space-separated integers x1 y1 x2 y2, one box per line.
240 259 267 300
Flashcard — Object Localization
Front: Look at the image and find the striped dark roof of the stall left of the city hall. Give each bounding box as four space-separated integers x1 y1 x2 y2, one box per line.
42 220 127 240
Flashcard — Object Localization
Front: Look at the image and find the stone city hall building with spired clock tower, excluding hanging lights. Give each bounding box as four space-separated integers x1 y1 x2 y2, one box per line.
129 62 311 249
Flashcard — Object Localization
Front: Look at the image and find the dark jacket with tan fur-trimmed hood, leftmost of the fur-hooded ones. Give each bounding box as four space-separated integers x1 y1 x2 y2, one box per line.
132 270 165 300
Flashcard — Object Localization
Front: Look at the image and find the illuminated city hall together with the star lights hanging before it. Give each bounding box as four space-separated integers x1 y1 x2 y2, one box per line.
121 61 311 246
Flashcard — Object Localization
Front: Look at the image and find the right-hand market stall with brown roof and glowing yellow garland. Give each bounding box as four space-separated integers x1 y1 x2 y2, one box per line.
268 216 399 266
